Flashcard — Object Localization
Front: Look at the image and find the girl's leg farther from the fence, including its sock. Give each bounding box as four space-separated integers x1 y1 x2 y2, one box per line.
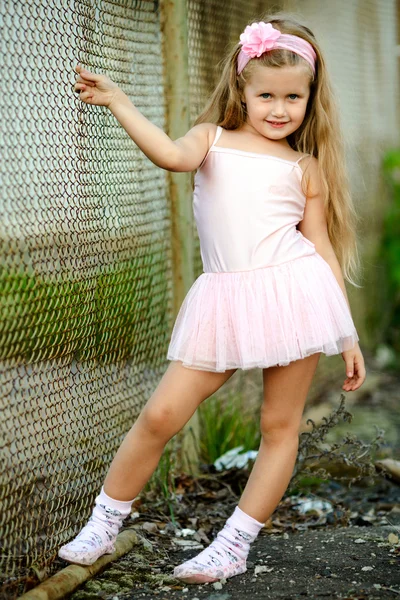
174 354 320 583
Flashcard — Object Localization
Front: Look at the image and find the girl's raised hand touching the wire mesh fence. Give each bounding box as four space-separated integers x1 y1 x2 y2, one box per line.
74 65 121 107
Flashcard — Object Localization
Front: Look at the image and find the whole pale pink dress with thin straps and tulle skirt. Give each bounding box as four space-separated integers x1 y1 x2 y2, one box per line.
167 126 359 372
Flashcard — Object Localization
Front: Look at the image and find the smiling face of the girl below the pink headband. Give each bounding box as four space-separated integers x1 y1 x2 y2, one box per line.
243 65 310 140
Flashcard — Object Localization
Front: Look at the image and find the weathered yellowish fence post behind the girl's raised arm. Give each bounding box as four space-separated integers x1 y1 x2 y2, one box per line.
160 0 199 474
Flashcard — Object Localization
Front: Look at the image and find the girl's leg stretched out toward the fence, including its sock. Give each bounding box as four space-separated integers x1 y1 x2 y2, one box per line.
58 361 236 565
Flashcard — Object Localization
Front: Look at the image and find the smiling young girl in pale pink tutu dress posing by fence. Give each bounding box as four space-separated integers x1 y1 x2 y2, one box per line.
59 17 365 583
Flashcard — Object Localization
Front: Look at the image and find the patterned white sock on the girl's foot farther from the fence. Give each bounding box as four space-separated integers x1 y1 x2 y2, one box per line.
174 506 264 583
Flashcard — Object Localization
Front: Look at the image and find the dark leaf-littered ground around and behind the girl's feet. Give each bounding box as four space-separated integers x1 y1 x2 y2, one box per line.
58 366 400 600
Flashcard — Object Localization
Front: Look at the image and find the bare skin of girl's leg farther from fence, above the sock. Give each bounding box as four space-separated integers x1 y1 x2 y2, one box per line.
239 353 321 523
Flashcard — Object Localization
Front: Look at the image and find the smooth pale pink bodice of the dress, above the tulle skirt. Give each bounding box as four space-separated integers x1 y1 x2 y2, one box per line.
193 126 316 273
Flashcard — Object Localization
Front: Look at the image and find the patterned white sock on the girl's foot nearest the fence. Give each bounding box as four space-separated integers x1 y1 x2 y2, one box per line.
58 488 133 565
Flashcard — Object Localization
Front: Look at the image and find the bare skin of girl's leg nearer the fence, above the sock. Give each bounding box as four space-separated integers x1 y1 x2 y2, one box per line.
104 361 236 500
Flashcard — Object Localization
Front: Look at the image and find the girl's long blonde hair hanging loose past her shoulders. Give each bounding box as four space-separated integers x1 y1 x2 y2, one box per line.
195 13 362 287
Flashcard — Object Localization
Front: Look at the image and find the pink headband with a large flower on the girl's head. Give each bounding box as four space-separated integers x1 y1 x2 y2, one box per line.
238 21 317 74
